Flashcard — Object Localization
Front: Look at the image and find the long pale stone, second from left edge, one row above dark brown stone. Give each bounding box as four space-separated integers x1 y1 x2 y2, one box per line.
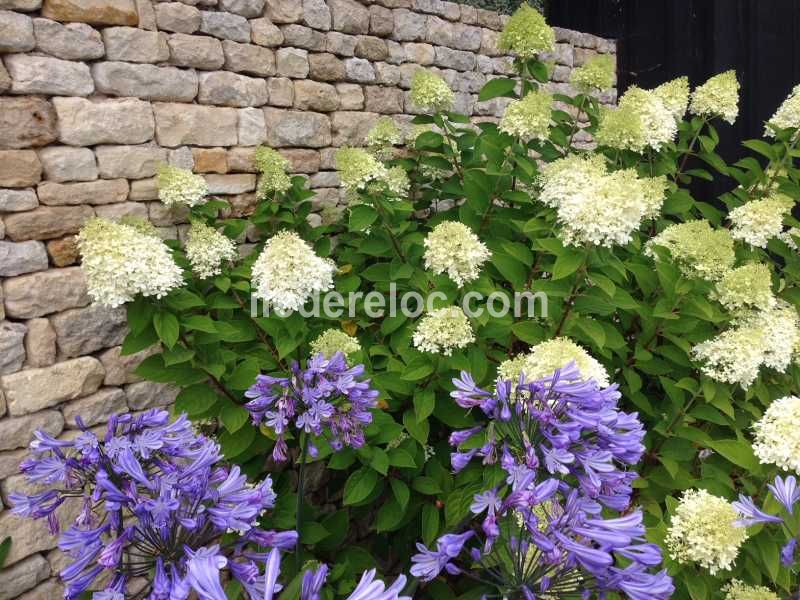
92 62 197 102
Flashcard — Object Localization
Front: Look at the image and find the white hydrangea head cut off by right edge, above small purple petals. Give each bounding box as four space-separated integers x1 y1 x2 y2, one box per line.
753 396 800 474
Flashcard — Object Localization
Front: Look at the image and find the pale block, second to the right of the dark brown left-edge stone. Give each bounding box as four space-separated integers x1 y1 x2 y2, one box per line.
153 103 238 148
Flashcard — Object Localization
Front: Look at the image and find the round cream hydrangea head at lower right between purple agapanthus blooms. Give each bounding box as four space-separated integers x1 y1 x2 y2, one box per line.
665 490 747 575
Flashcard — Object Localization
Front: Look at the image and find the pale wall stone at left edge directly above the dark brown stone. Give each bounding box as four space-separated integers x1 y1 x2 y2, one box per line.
5 54 94 96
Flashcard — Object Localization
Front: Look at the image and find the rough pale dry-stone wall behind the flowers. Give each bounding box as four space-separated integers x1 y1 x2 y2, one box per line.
0 0 615 600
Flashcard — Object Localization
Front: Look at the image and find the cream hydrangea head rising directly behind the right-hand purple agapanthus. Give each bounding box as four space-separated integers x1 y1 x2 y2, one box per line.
497 337 609 388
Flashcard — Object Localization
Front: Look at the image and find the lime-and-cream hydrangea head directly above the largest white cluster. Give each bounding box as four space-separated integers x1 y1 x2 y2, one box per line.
596 86 678 152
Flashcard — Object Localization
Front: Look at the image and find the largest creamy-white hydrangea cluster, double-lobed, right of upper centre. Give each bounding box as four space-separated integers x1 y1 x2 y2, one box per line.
539 154 667 247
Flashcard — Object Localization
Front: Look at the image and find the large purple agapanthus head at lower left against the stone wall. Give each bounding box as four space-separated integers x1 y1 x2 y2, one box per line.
11 410 297 600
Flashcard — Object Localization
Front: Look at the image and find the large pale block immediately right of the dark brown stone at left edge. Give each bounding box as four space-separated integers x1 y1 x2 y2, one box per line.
53 98 155 146
